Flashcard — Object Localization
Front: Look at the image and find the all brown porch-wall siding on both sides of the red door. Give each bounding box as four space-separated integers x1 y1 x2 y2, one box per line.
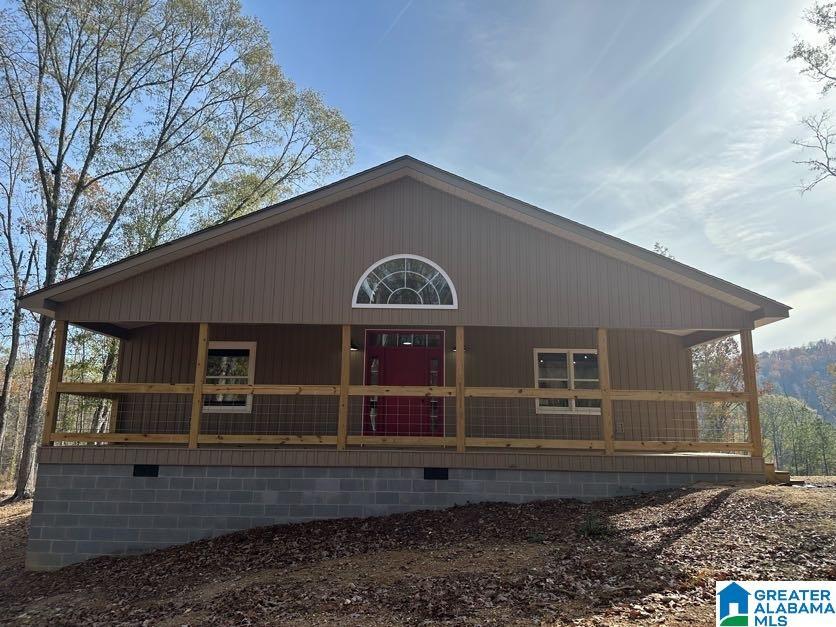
118 324 696 440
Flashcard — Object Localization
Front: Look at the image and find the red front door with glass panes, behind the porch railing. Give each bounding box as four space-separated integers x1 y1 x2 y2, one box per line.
363 330 444 436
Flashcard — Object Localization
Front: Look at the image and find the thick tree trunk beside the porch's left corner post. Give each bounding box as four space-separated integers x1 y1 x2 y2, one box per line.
11 316 52 499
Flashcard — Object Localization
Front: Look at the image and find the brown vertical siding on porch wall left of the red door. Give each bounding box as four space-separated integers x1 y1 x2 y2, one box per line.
117 324 339 435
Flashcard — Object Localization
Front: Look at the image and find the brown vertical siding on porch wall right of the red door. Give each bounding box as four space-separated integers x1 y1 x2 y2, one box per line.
465 327 696 440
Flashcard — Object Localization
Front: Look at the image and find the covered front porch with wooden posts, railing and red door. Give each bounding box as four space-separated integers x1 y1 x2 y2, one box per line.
42 320 763 472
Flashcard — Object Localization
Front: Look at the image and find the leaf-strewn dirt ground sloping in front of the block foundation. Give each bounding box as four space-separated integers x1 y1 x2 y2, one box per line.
0 477 836 626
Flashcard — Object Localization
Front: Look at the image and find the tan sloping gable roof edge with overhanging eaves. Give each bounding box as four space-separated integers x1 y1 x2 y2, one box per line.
21 156 790 326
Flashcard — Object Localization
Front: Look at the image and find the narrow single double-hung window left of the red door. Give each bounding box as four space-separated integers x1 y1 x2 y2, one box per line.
203 342 255 414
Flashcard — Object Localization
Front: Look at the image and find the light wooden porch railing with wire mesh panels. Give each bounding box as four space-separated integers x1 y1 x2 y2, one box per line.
49 383 753 452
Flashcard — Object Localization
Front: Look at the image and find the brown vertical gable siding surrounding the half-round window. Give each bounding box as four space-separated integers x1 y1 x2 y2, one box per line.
58 178 751 329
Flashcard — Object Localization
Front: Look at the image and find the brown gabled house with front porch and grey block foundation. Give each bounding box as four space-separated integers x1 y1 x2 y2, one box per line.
23 157 789 568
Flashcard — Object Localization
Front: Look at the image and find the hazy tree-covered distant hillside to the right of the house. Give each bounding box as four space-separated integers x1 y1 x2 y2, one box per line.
758 340 836 424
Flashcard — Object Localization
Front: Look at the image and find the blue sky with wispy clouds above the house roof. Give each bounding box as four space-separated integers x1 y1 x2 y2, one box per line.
244 0 836 350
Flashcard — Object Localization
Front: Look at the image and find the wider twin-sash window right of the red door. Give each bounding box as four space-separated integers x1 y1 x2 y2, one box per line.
534 348 601 414
